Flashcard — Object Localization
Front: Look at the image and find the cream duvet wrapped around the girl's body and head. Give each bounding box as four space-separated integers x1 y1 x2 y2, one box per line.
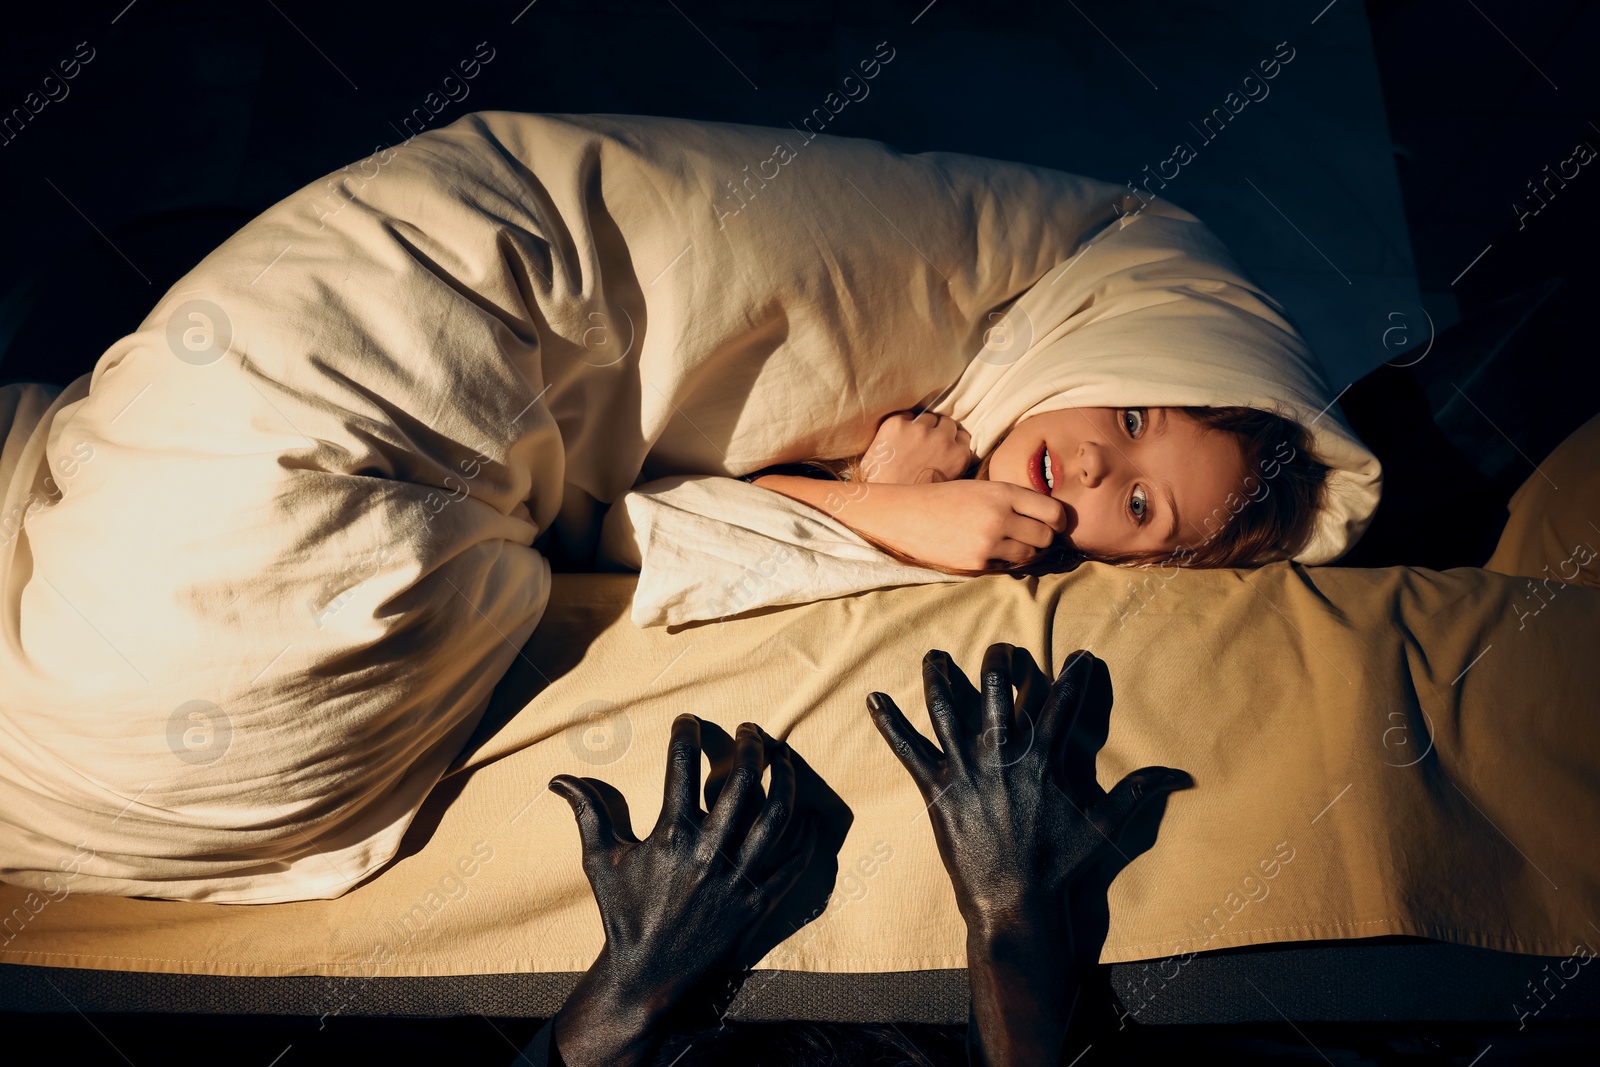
0 112 1376 902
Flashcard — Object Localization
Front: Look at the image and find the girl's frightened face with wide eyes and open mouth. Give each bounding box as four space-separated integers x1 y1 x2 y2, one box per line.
987 408 1245 555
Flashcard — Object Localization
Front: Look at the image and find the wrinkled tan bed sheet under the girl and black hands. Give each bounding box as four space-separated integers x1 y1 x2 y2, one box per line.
0 559 1600 979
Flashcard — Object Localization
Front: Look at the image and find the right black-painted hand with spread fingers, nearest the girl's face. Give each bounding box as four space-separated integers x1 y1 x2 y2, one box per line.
867 643 1192 1065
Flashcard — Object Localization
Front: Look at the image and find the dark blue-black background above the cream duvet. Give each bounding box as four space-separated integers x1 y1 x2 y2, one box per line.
0 0 1600 395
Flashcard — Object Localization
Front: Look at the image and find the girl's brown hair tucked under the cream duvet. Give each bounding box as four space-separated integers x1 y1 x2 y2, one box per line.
784 408 1328 577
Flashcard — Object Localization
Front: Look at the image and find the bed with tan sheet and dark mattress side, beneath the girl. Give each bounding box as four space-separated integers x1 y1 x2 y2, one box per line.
0 418 1600 1022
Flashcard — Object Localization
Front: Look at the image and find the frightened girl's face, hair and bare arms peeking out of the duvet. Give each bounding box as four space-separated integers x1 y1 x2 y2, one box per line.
746 406 1328 574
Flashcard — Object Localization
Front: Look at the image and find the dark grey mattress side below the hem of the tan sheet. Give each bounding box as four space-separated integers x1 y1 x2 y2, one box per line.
0 939 1600 1025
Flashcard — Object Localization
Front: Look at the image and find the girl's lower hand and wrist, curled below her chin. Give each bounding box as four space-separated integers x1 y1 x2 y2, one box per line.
834 478 1067 571
